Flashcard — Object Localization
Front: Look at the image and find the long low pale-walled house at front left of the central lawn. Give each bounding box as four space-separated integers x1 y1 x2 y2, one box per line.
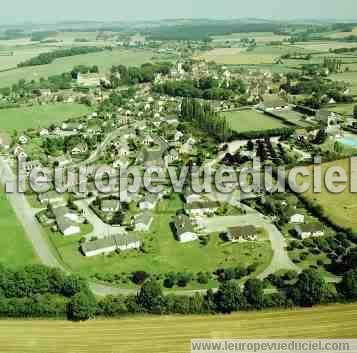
81 234 141 257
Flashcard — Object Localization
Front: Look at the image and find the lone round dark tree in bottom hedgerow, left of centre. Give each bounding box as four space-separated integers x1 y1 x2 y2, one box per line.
137 280 164 313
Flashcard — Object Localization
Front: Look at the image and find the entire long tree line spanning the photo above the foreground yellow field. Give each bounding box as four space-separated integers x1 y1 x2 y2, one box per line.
0 260 357 320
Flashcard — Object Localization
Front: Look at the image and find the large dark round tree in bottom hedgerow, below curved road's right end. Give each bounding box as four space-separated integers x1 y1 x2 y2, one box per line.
293 269 325 306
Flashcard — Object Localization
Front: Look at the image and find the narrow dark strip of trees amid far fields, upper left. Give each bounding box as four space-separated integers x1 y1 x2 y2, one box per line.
17 47 103 67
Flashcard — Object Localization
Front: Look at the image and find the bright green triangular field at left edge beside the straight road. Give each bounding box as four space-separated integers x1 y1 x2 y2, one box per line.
0 187 38 267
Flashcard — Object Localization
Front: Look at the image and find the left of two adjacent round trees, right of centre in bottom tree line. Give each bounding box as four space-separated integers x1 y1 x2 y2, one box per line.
215 280 245 314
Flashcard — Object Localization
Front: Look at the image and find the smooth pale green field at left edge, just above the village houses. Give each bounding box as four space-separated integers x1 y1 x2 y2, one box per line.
0 103 90 132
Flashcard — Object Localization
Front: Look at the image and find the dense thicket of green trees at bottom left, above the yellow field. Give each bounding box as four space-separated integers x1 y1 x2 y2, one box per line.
0 265 96 320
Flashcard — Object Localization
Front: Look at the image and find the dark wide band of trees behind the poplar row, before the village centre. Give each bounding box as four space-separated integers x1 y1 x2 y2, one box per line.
154 77 246 100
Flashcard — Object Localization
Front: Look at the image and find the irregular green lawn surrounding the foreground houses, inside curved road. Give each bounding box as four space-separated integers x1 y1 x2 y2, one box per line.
46 195 272 285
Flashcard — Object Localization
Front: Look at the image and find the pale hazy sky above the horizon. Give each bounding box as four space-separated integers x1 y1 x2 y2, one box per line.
0 0 357 23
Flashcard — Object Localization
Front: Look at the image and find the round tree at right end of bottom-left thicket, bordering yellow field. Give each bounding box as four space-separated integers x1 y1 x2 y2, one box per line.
67 291 97 321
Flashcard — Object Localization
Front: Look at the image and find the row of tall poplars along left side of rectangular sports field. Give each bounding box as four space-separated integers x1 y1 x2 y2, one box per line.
180 98 231 141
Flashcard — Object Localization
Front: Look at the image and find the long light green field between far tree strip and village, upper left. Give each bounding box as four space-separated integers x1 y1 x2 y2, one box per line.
0 49 160 87
